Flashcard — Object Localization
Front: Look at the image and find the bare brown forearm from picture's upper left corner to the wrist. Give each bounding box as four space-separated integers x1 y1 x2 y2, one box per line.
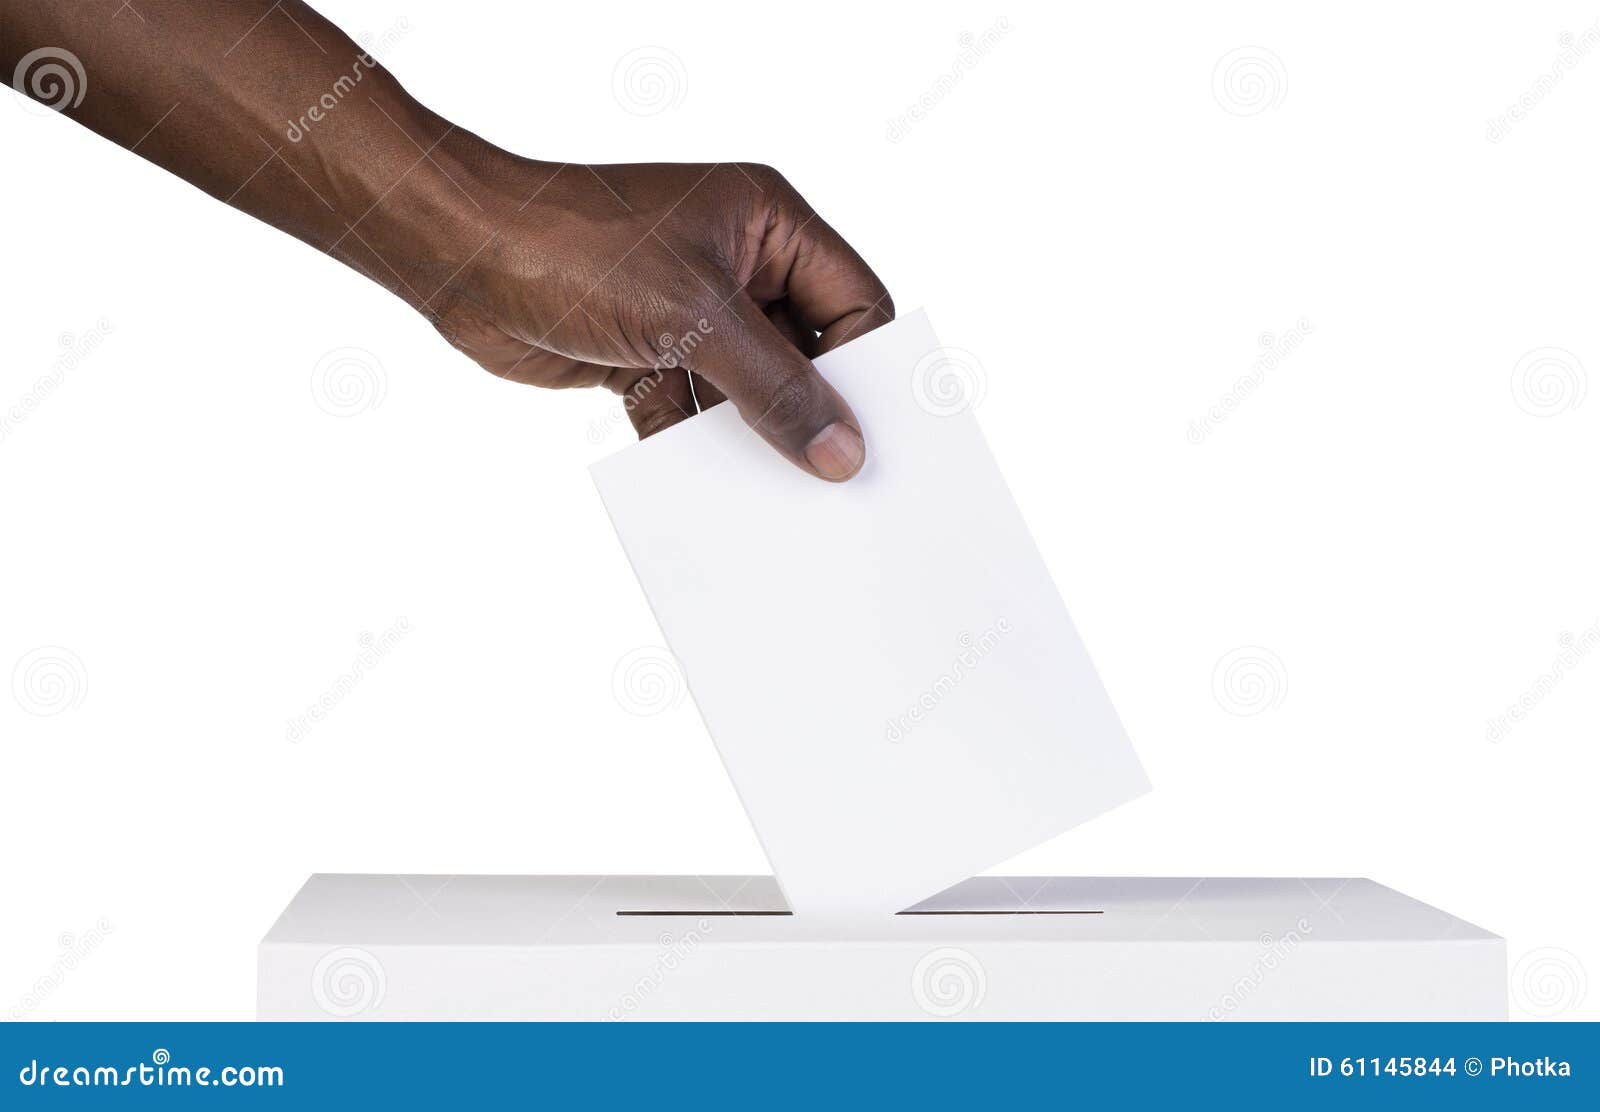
0 0 530 315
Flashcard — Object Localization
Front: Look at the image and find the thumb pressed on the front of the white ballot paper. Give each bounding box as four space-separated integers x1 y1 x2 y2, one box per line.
691 296 867 483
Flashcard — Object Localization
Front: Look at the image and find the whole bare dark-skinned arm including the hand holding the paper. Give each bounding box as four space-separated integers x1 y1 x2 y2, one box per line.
0 0 894 480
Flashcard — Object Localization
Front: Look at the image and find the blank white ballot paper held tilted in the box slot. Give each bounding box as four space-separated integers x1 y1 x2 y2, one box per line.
592 312 1149 917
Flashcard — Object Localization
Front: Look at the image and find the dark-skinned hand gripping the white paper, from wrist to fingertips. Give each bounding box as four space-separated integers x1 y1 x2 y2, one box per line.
422 160 894 482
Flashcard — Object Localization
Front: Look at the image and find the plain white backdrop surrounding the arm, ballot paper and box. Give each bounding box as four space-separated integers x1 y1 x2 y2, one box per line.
0 0 1600 1019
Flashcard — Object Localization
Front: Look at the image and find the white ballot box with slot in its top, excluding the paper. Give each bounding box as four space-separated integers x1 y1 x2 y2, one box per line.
258 875 1506 1021
